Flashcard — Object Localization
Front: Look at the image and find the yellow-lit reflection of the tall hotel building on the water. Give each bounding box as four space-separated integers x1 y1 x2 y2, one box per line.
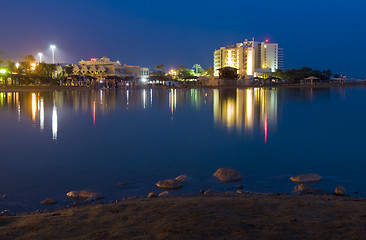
213 88 278 142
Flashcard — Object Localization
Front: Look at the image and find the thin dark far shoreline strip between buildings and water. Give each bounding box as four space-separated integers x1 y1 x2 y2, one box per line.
0 83 366 92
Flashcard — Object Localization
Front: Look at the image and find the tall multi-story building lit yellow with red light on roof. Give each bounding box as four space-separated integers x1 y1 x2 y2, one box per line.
214 38 283 76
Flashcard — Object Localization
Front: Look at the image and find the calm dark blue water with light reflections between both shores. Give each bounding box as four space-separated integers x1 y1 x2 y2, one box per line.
0 88 366 212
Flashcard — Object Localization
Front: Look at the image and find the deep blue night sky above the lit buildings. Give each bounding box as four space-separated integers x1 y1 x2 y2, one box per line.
0 0 366 78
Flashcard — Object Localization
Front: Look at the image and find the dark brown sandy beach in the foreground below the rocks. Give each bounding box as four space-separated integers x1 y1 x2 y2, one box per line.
0 194 366 239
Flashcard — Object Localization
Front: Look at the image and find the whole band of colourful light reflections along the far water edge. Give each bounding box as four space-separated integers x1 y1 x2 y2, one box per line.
0 88 338 143
